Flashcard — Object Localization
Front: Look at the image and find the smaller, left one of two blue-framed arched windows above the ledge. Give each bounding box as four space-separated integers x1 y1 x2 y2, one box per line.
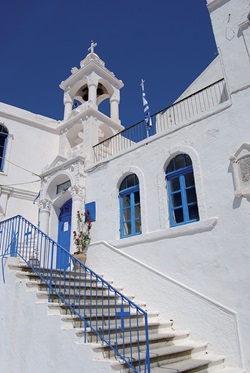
119 174 141 238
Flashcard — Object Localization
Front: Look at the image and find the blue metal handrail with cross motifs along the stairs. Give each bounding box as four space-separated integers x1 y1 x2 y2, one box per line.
0 215 150 373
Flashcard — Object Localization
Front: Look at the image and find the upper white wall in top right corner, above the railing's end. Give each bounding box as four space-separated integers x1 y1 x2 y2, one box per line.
207 0 250 93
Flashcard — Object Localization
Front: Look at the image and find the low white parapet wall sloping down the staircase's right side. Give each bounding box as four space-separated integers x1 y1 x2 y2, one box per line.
87 242 242 366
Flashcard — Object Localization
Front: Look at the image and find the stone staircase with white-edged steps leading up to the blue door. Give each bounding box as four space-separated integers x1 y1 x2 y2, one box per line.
10 264 243 373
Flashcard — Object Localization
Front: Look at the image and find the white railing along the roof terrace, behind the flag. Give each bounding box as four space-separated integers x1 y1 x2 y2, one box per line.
93 79 229 162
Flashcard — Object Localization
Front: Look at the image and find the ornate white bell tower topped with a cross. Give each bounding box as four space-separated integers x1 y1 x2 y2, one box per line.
59 41 124 160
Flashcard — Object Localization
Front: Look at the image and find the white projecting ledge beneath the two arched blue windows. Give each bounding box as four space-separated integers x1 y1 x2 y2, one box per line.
109 218 218 248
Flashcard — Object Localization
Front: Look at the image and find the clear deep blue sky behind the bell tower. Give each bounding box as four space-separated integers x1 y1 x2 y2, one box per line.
0 0 217 127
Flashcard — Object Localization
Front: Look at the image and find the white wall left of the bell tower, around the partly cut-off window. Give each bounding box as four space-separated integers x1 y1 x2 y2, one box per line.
0 103 59 224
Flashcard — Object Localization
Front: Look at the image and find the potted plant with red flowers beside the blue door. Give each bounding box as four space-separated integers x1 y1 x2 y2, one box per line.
73 210 92 268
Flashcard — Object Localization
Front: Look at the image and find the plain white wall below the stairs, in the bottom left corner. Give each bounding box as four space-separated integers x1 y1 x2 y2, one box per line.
0 259 110 373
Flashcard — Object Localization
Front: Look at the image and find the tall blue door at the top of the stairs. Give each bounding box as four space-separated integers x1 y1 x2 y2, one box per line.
56 199 72 269
